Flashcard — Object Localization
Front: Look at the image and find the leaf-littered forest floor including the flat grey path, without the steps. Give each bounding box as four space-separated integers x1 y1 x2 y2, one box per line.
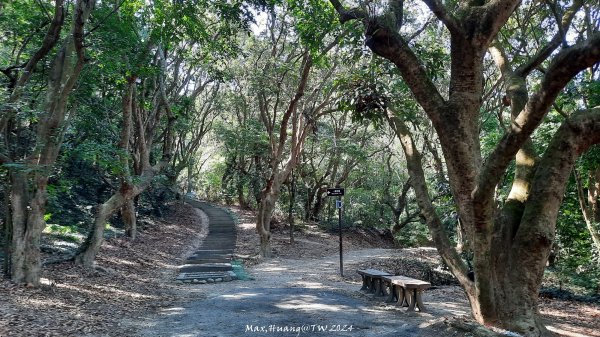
0 204 600 337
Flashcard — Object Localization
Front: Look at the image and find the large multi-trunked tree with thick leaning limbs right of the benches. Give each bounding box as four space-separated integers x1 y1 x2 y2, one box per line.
330 0 600 336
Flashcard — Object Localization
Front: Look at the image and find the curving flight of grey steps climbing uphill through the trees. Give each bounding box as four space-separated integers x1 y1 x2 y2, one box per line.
177 200 236 283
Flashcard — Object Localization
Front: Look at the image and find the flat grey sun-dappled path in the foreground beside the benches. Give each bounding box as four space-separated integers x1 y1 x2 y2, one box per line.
134 249 468 337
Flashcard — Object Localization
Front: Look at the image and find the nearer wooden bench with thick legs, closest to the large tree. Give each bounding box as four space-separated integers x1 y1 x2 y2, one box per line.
381 275 431 312
